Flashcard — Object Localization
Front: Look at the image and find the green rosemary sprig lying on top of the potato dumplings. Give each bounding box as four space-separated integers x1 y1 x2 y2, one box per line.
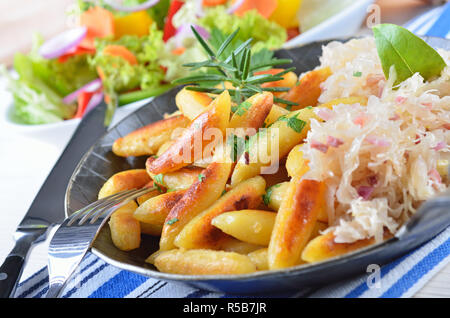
173 27 297 106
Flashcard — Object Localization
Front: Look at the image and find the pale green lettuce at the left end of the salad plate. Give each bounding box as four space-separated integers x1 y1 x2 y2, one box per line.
2 33 97 124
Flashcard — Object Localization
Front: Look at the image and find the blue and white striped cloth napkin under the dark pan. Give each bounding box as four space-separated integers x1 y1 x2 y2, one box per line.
15 3 450 298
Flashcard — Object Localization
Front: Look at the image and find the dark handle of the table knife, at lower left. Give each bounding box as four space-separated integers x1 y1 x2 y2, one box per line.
0 230 42 298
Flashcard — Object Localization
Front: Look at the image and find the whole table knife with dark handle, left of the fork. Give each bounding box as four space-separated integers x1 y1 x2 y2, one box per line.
0 102 107 298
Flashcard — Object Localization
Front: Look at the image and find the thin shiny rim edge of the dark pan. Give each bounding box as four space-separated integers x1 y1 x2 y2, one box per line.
65 37 450 289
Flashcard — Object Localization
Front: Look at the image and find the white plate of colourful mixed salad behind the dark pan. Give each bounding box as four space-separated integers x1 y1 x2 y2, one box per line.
2 0 373 145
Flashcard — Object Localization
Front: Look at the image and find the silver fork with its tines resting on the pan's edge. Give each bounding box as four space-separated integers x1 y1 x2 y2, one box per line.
46 188 154 298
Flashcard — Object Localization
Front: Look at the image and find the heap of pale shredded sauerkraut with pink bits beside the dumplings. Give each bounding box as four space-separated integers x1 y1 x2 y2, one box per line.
303 37 450 243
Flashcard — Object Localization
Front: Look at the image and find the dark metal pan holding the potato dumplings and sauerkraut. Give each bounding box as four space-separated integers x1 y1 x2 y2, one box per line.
66 38 450 294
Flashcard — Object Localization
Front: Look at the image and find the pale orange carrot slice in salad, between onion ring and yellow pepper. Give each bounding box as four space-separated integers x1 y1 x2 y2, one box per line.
80 6 114 49
